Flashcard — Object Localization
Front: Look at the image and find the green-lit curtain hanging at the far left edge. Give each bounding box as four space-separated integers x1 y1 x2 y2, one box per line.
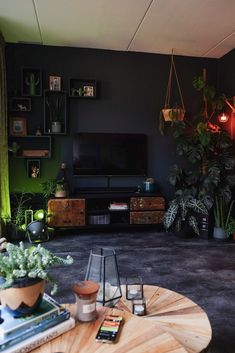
0 33 11 234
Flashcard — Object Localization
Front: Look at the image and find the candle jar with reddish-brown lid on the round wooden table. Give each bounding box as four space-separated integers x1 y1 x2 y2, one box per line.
73 281 99 322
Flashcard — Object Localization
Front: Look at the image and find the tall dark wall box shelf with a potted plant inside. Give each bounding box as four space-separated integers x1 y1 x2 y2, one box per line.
44 90 67 135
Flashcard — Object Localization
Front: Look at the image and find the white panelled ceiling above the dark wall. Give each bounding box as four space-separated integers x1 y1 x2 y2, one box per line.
0 0 235 58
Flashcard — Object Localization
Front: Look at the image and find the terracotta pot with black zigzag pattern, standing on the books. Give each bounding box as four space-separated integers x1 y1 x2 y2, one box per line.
0 277 45 317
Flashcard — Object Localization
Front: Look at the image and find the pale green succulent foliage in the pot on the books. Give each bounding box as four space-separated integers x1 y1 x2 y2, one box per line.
0 242 73 295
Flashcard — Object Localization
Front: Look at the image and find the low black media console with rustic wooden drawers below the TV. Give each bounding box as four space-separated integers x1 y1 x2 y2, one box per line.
48 189 165 229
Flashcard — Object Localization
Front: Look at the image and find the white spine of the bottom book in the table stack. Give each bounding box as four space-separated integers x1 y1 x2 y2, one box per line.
1 317 75 353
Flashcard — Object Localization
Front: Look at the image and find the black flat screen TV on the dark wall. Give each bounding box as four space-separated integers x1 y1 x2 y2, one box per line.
73 133 148 176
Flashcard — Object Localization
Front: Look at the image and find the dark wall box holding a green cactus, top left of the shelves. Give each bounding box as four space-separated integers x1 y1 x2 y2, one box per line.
22 68 42 97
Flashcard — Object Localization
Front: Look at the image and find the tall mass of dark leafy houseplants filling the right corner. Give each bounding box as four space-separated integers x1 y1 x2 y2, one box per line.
163 71 235 236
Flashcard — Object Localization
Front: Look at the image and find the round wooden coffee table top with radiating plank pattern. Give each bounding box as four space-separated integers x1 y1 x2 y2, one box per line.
30 285 212 353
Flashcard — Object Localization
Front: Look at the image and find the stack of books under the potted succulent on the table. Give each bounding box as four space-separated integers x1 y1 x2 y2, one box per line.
0 294 75 353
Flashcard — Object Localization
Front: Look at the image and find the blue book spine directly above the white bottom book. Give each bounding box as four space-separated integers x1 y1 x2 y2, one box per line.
0 310 70 352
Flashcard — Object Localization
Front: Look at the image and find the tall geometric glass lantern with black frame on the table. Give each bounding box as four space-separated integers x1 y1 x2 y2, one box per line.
85 248 122 306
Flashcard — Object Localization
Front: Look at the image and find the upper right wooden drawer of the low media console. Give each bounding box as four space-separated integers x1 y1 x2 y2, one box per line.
130 196 165 211
